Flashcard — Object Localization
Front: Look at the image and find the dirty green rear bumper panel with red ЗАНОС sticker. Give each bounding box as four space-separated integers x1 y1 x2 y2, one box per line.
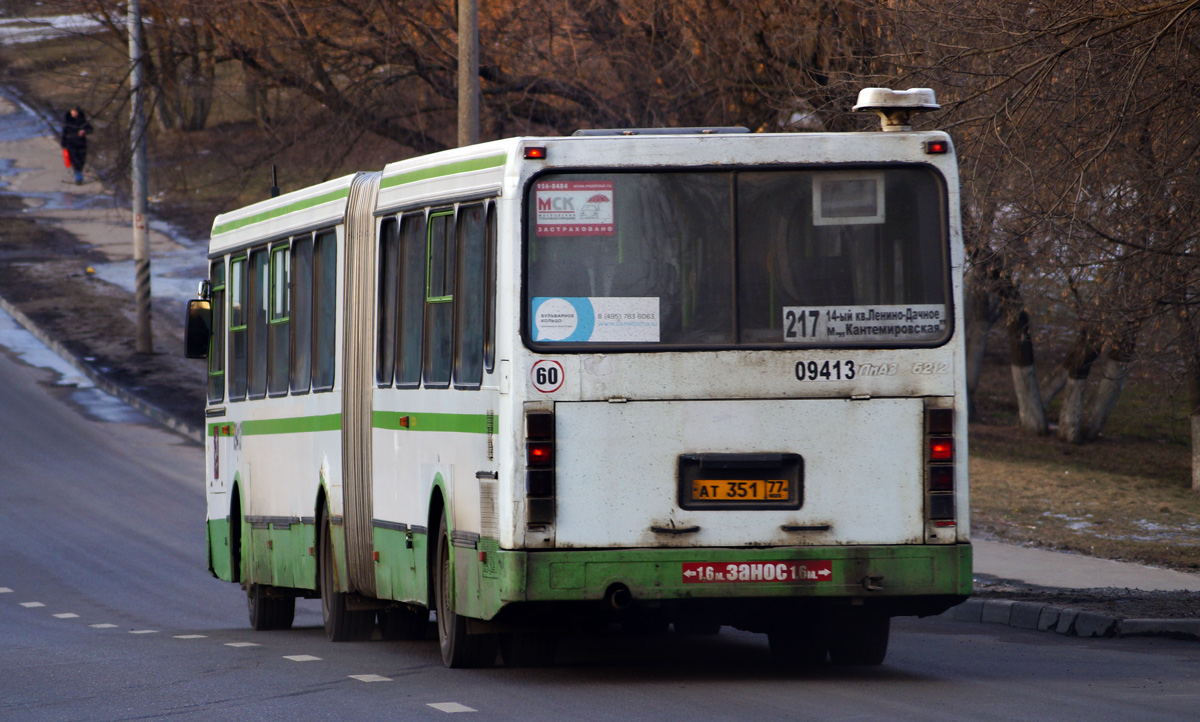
456 544 972 619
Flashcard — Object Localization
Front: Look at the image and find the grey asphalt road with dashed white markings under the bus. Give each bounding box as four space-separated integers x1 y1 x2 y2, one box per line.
0 350 1200 722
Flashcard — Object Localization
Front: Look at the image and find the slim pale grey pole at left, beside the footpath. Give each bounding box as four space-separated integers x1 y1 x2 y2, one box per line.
125 0 154 354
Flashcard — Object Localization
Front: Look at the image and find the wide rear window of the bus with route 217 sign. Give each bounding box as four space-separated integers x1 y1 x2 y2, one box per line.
524 168 949 351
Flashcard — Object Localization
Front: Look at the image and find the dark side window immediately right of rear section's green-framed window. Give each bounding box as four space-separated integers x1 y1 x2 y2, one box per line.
454 204 487 389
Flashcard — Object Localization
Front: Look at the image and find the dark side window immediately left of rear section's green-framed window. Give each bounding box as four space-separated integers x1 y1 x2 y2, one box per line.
396 211 427 389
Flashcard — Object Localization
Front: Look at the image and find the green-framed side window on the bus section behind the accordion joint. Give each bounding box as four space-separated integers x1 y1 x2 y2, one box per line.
424 211 455 389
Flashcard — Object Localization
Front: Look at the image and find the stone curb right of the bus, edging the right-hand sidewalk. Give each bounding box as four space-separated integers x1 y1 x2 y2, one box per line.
941 600 1200 642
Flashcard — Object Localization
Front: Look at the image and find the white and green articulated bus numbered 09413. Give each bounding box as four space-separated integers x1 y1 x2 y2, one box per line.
187 89 971 667
